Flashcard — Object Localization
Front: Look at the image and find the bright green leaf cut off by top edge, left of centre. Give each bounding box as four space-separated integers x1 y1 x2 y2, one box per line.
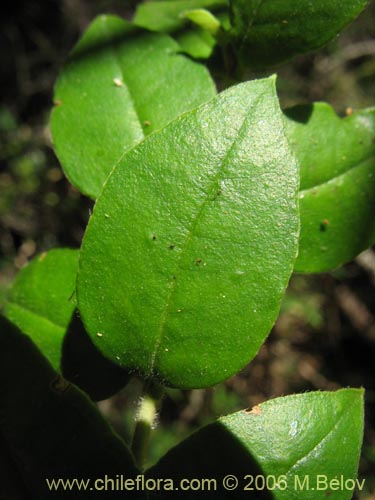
133 0 228 32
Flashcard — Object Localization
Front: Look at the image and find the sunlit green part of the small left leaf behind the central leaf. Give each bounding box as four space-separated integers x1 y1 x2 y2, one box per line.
4 248 78 370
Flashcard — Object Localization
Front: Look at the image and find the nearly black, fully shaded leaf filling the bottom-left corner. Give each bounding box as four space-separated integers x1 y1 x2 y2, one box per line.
0 317 144 500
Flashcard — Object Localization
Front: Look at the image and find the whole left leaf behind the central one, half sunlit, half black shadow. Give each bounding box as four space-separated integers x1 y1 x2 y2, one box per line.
4 249 130 401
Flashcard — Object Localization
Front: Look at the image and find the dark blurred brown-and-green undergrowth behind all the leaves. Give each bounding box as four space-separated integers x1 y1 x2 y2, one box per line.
0 0 375 500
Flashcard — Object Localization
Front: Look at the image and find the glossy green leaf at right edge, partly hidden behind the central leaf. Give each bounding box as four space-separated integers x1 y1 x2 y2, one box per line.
285 103 375 272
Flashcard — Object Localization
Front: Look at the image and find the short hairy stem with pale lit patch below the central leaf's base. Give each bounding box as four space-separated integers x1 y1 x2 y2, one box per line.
131 382 163 471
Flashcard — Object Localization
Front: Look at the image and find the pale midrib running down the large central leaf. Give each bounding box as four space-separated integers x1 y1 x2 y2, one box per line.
150 94 263 375
